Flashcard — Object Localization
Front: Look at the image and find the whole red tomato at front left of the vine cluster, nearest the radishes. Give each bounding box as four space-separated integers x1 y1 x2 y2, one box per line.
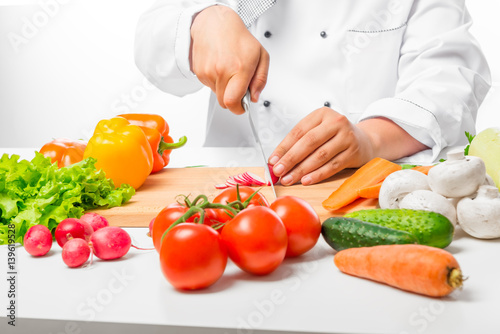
160 223 227 290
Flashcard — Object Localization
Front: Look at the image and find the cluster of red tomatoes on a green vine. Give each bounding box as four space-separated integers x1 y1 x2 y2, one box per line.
150 186 321 290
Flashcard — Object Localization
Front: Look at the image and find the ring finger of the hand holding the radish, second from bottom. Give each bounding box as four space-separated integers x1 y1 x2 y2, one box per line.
281 132 349 185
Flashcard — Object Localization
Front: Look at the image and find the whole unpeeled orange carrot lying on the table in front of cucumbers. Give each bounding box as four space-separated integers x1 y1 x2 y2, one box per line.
334 244 463 297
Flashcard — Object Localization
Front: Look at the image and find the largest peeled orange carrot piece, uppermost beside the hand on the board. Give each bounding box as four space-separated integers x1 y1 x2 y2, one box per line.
322 158 401 211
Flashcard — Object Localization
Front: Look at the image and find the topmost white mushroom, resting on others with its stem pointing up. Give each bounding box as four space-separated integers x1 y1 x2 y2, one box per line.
429 150 486 197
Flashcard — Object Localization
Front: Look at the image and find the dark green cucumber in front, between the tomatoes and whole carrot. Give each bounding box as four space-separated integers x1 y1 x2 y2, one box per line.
321 217 418 251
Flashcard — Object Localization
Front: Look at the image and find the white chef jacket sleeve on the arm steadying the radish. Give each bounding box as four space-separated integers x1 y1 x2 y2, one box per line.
360 0 491 161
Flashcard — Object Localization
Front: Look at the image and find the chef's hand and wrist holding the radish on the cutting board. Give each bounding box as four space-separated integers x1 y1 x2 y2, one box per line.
269 107 427 185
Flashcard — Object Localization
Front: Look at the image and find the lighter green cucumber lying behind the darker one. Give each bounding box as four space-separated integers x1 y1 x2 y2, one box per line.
345 209 454 248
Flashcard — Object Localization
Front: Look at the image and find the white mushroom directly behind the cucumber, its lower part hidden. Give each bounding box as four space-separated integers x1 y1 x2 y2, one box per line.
399 190 457 226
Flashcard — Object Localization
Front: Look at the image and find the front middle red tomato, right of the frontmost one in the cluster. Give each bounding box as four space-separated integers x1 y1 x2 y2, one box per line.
222 206 287 275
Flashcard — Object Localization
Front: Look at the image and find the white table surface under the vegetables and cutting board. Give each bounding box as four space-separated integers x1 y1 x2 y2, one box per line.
0 149 500 334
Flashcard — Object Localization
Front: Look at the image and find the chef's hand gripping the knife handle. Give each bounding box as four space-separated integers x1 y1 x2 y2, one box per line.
191 6 269 114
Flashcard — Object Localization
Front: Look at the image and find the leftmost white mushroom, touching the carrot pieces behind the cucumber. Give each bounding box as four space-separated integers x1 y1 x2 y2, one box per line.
378 167 435 209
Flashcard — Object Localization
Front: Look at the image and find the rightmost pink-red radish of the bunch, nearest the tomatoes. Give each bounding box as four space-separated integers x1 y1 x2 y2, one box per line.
90 226 132 260
